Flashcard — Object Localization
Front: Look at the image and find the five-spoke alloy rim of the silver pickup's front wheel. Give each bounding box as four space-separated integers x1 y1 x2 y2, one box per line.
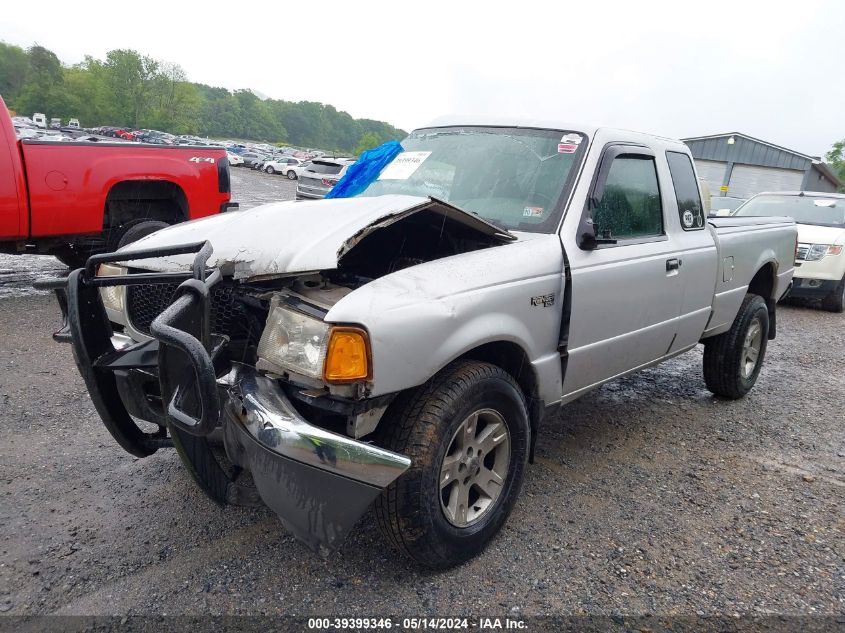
439 409 511 528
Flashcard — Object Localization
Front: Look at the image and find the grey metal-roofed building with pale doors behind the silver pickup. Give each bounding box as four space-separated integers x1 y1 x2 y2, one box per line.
681 132 842 198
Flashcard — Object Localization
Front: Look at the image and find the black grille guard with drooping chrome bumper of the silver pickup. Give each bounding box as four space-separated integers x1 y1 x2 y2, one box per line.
40 242 410 552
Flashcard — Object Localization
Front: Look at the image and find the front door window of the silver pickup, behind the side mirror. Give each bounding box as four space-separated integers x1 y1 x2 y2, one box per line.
593 154 663 240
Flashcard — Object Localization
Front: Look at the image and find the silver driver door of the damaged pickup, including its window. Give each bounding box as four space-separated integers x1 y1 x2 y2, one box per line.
563 144 683 400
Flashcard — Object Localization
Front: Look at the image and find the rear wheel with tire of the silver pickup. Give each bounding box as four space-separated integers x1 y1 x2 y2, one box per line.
704 294 769 400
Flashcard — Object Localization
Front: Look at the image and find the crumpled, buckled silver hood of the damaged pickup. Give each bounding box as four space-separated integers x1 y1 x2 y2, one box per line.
121 195 516 279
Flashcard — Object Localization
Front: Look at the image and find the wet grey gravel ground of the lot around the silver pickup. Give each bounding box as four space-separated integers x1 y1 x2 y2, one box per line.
0 170 845 616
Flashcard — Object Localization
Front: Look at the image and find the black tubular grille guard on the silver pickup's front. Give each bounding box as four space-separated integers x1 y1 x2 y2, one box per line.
34 241 225 446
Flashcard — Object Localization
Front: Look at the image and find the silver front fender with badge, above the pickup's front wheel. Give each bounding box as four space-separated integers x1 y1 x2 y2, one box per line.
326 235 563 401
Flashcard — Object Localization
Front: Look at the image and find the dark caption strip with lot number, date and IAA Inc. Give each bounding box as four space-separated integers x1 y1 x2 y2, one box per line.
0 614 845 633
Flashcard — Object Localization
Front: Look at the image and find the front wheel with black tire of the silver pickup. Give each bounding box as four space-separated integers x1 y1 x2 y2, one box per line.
375 361 531 569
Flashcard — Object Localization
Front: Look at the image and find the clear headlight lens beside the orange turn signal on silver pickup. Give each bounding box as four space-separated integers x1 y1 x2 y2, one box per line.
258 297 329 378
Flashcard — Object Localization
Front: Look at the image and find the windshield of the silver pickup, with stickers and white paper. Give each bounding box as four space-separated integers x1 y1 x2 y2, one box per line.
352 127 586 233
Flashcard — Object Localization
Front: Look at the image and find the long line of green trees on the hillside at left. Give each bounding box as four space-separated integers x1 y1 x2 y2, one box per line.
0 42 405 148
